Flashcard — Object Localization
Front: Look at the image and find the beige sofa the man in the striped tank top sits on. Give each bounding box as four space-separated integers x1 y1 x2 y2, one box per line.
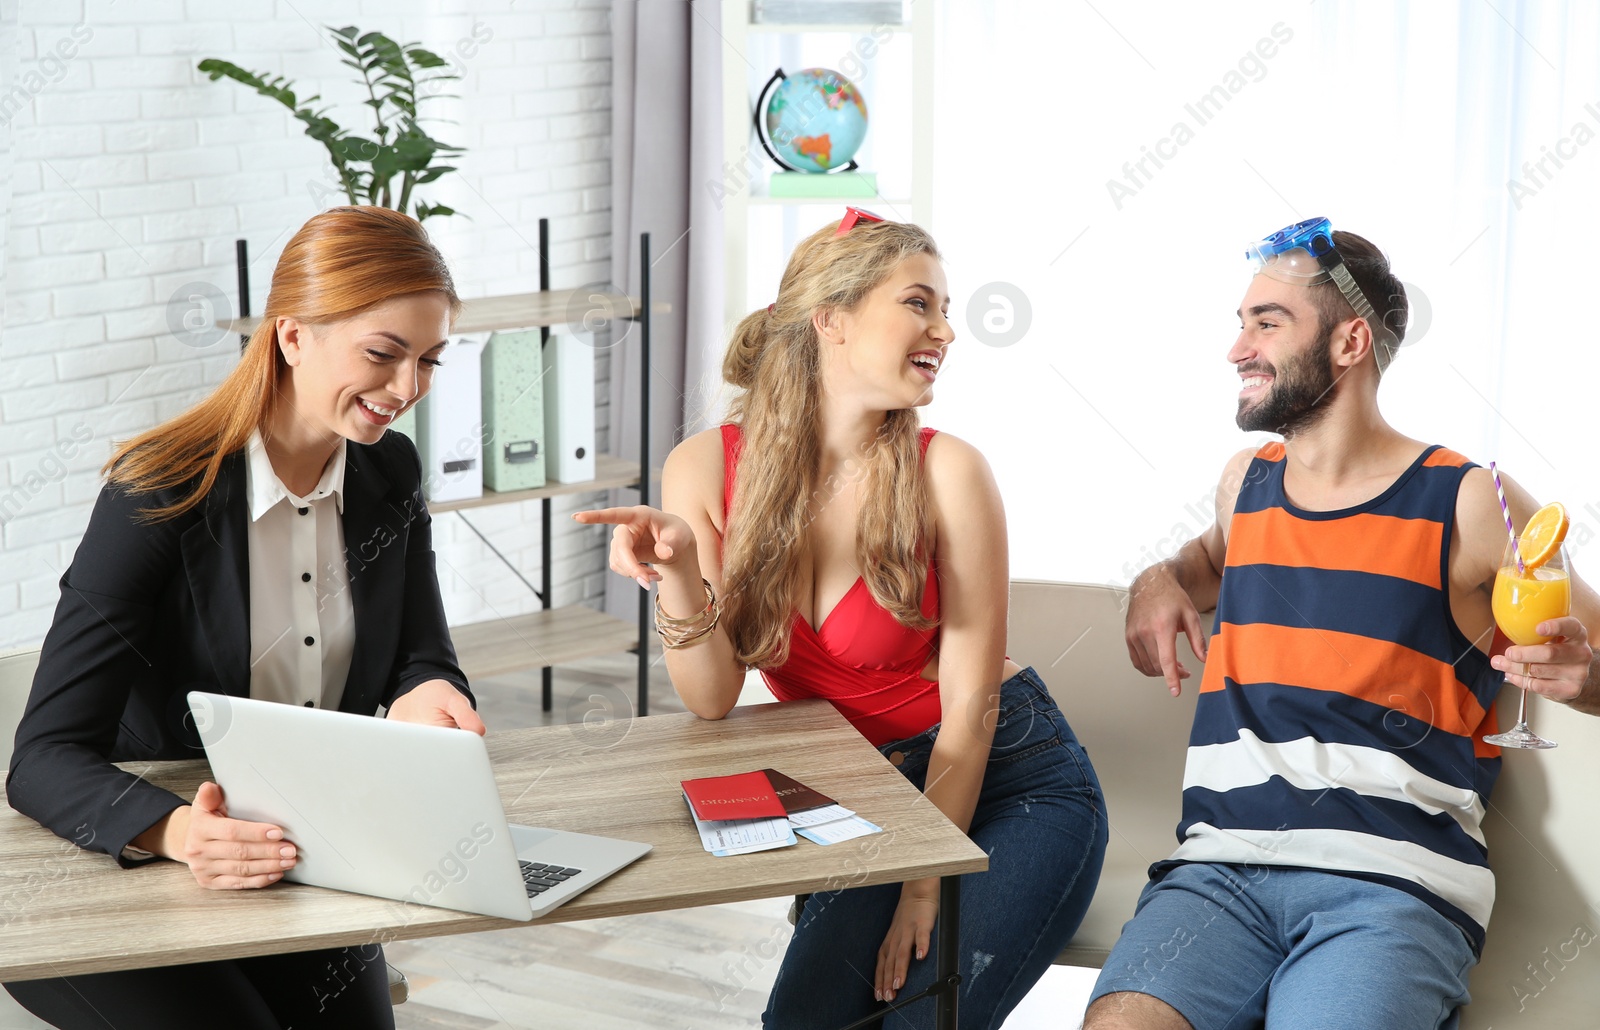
1006 579 1600 1030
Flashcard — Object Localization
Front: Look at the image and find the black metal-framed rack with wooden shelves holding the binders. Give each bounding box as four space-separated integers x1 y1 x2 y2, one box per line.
222 219 672 715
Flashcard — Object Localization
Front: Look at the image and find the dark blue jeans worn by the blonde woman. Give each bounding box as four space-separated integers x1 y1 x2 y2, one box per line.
762 669 1107 1030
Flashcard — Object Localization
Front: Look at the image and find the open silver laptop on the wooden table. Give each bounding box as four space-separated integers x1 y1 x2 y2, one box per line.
189 691 650 920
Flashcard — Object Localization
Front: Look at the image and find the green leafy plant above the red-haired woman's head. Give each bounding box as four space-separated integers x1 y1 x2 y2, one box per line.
198 26 464 221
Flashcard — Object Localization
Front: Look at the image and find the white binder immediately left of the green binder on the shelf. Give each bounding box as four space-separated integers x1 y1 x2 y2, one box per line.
416 333 488 501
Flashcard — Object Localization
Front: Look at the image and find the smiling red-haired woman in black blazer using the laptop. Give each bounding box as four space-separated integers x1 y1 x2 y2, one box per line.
6 208 483 1030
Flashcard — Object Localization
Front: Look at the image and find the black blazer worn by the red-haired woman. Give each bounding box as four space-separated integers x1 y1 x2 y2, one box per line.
6 433 472 865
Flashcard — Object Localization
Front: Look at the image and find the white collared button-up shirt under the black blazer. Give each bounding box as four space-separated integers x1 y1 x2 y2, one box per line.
245 432 355 709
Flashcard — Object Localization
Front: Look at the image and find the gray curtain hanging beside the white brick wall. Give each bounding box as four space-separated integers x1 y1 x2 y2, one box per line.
606 0 723 619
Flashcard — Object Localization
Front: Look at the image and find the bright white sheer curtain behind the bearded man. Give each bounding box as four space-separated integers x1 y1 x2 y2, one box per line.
918 0 1600 584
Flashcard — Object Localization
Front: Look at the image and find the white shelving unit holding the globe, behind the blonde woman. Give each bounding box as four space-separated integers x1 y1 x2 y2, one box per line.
720 0 934 326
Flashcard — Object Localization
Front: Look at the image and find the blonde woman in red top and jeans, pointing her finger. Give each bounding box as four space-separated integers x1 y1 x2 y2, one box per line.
574 210 1107 1030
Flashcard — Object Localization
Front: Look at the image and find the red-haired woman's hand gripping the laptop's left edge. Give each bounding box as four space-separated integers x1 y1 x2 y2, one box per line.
144 780 296 891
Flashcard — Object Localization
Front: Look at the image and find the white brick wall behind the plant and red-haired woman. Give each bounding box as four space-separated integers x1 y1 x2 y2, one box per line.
0 0 611 648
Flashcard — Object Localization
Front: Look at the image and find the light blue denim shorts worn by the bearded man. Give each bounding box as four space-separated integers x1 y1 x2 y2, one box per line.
1093 862 1477 1030
